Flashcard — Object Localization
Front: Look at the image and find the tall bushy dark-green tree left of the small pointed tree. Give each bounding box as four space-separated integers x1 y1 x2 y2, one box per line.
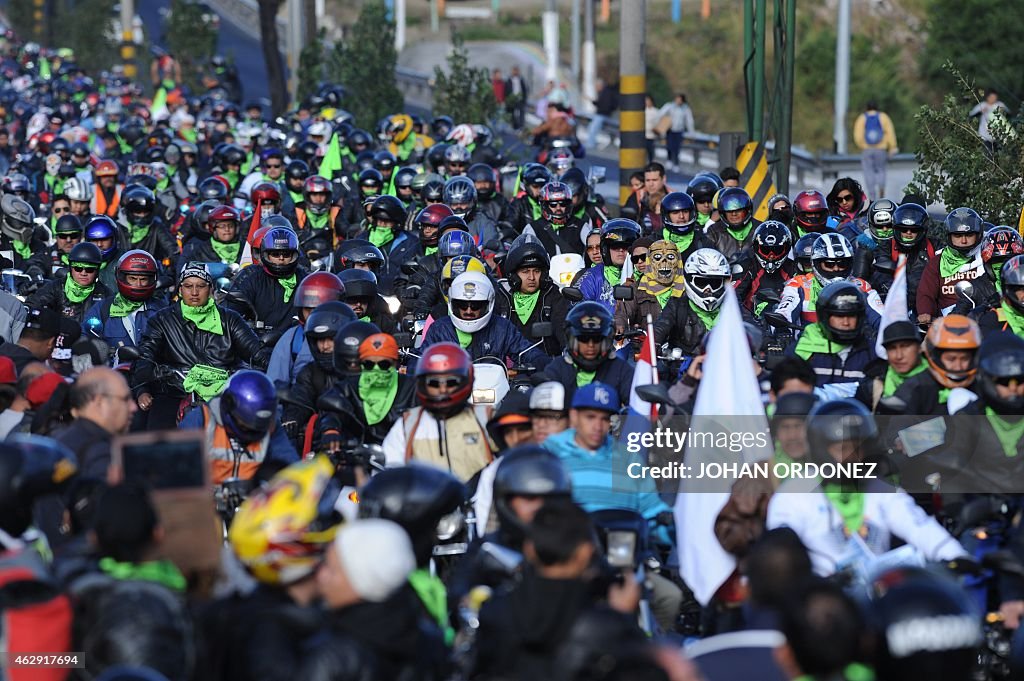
329 0 403 129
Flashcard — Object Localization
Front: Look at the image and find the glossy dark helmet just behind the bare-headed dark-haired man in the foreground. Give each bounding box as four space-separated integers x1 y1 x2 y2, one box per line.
494 444 572 533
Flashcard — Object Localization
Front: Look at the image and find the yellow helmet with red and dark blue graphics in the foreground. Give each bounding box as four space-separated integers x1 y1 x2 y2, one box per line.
227 456 342 585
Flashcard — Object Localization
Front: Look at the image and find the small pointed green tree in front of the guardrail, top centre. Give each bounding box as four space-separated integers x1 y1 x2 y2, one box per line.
434 31 498 123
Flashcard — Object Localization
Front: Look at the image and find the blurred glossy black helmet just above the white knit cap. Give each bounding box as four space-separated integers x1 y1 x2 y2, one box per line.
359 464 466 566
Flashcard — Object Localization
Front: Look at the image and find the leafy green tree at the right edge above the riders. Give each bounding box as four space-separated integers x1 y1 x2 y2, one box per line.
908 71 1024 225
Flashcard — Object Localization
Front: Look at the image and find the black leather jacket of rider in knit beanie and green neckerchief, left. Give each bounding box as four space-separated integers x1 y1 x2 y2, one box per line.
131 304 270 397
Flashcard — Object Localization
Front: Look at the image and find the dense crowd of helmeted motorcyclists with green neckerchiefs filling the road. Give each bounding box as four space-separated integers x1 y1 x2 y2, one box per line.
0 29 1024 681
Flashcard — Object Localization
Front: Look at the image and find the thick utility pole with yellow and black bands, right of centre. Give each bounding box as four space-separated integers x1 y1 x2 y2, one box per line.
618 0 647 205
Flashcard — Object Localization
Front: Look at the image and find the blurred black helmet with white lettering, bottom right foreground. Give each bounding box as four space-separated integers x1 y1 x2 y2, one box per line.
867 567 982 681
